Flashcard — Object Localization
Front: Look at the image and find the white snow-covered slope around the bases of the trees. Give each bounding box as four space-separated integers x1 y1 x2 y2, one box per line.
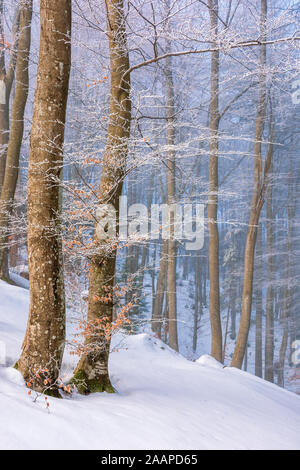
0 281 300 449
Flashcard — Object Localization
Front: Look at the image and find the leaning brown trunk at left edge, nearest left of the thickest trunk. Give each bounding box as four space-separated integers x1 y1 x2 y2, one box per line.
0 0 32 278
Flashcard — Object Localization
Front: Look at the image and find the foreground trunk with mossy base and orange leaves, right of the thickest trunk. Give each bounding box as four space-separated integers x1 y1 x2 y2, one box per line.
73 0 131 393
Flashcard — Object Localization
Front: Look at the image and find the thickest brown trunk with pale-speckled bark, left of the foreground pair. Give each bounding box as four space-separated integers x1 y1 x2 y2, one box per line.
17 0 71 394
